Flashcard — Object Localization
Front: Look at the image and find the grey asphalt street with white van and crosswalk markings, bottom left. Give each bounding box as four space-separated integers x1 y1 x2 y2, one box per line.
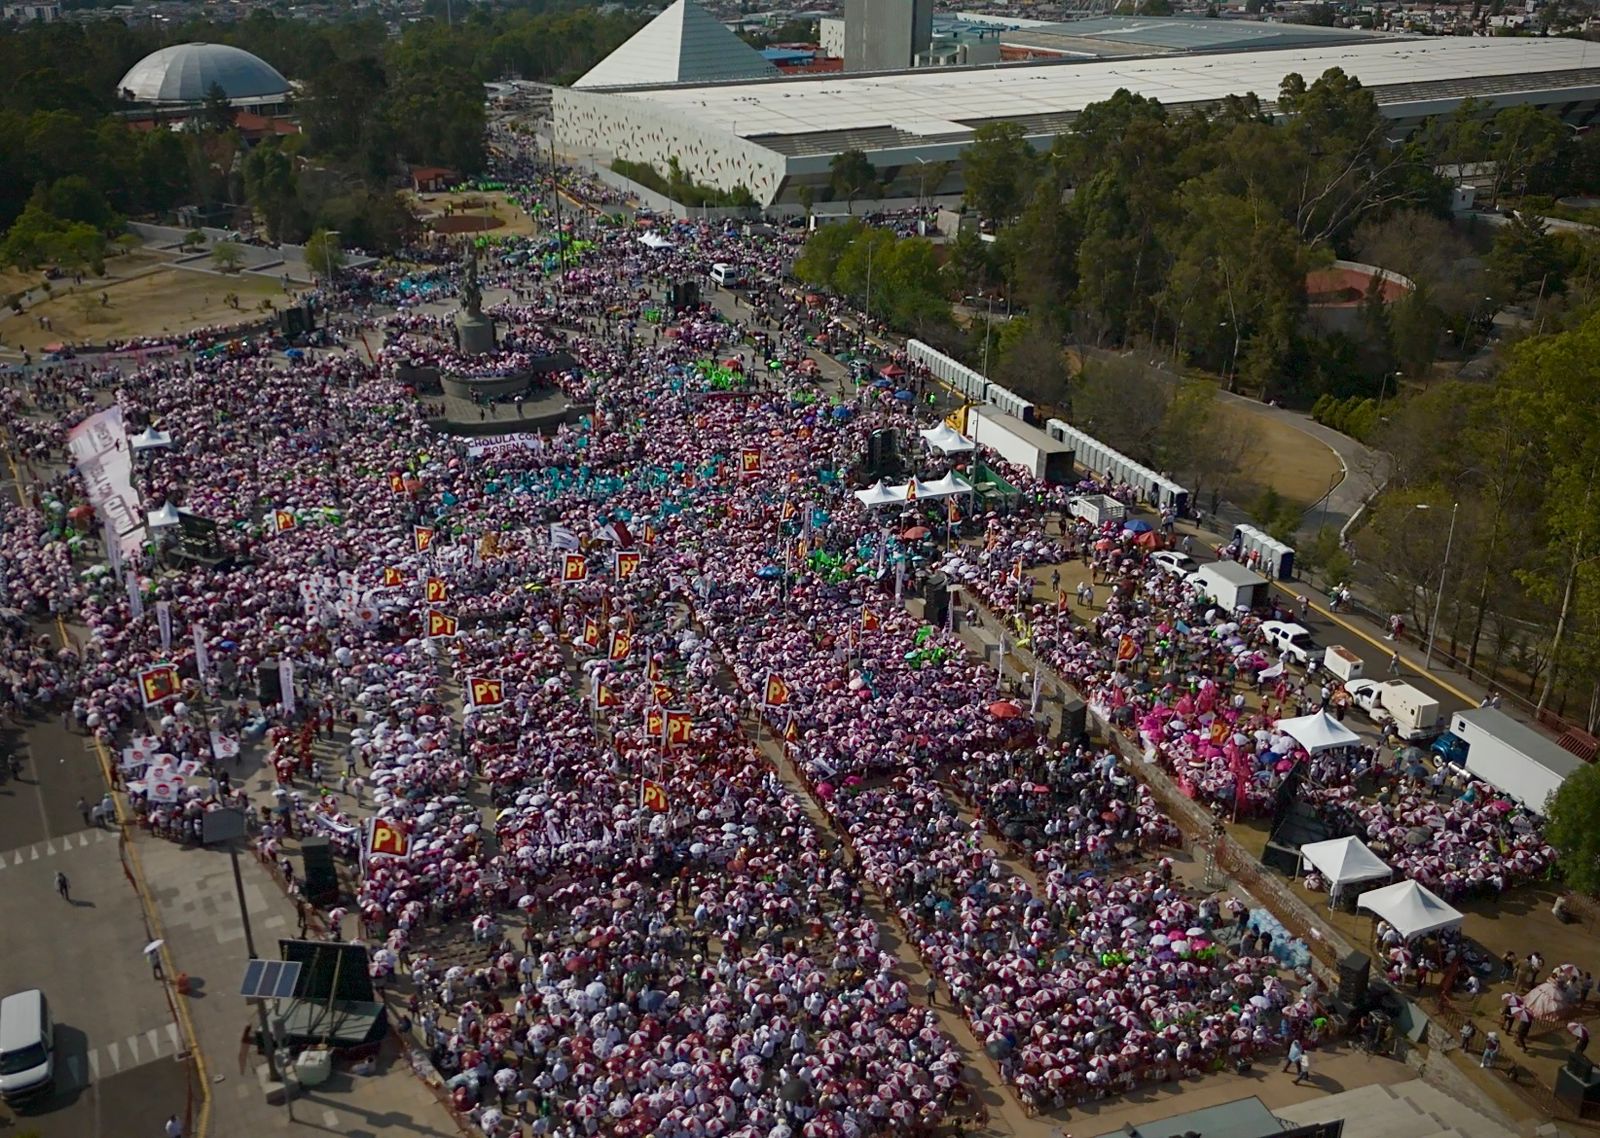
0 722 189 1138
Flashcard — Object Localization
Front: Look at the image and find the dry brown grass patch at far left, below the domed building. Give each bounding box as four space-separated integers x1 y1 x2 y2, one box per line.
0 269 286 352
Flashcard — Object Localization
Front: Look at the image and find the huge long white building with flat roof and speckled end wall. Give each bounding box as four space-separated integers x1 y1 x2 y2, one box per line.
552 38 1600 205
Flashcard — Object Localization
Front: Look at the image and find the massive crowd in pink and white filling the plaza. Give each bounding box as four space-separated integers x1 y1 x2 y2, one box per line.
0 157 1547 1138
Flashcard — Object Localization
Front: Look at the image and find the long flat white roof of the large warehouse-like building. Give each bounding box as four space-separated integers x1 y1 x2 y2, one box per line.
608 37 1600 138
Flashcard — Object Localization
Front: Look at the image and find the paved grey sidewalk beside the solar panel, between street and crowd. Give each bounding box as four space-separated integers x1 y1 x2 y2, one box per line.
134 832 459 1138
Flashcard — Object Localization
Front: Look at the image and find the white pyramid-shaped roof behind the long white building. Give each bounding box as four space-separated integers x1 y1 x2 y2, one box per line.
573 0 778 88
